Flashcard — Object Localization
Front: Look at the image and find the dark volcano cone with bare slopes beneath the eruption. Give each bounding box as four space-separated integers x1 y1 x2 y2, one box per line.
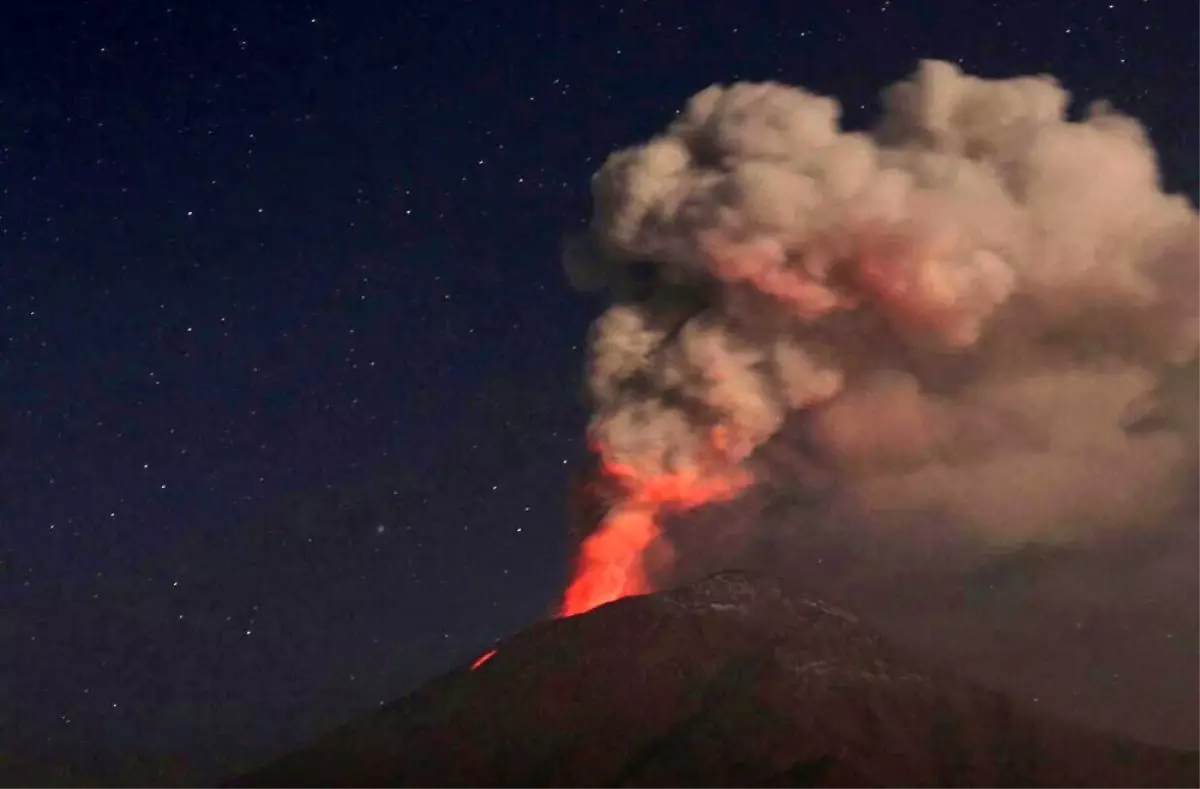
226 572 1200 789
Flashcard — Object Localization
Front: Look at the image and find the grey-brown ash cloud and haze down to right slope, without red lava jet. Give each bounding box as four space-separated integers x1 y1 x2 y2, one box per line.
564 61 1200 747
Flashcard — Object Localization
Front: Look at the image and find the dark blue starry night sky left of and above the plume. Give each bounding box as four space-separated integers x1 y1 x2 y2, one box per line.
0 0 1200 785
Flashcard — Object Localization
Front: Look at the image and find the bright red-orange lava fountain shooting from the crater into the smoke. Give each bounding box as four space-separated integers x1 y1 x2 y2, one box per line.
559 433 749 616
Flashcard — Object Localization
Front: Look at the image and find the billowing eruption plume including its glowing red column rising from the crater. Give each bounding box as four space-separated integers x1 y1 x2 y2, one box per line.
563 61 1200 614
